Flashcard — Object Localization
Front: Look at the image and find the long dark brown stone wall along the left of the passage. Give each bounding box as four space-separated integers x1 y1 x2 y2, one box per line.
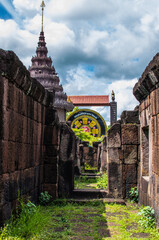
0 50 75 223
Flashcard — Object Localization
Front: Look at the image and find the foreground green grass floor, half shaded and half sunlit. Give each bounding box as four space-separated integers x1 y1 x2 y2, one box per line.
0 200 159 240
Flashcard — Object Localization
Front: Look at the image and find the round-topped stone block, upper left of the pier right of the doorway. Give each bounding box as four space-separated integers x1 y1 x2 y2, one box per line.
107 123 121 148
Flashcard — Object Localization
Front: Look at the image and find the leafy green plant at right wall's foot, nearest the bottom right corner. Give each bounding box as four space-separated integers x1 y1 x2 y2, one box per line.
138 206 156 228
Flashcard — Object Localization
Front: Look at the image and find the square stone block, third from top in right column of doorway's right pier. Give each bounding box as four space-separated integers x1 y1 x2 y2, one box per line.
122 145 138 164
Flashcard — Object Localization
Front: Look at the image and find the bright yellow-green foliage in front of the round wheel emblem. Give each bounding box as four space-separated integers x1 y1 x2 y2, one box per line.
72 128 103 146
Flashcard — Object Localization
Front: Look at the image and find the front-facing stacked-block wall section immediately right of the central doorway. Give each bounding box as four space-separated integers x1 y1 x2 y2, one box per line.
107 110 139 198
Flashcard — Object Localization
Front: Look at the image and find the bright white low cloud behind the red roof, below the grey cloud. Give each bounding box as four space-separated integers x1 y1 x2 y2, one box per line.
64 66 138 123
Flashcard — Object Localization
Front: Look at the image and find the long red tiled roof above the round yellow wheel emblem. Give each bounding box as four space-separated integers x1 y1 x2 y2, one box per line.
67 95 109 106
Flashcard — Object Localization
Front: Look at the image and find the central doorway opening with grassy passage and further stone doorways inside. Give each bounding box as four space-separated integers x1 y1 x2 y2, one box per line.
74 142 107 197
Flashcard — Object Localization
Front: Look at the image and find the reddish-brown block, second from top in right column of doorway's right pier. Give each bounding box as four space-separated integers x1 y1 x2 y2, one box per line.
121 124 139 145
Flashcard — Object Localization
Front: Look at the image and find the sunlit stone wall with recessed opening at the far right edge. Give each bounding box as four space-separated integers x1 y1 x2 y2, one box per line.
133 54 159 225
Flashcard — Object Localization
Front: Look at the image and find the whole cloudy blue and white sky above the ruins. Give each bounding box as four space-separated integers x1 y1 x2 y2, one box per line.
0 0 159 124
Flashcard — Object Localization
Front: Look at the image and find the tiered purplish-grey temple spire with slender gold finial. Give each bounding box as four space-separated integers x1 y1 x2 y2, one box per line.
29 1 74 122
